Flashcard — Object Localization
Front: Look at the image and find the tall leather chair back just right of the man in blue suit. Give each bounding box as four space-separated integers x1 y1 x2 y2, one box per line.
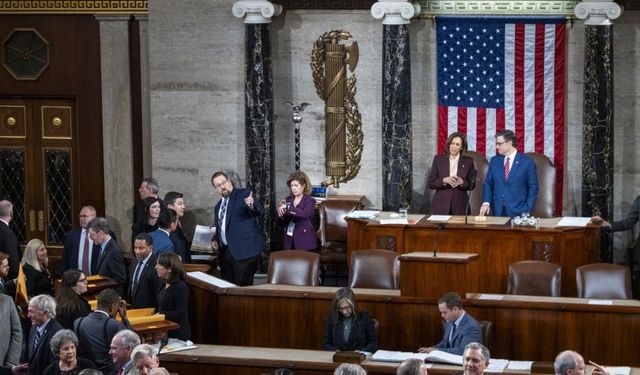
526 152 556 217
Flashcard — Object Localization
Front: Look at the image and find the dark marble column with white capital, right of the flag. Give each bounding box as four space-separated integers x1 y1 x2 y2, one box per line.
575 1 621 262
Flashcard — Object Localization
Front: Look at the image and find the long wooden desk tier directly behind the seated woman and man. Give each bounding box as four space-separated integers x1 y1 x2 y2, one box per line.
188 279 640 366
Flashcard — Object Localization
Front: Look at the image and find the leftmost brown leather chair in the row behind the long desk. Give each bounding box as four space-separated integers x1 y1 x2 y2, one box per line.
267 250 320 286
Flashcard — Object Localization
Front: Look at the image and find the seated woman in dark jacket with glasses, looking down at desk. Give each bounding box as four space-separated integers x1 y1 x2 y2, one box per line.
322 288 378 353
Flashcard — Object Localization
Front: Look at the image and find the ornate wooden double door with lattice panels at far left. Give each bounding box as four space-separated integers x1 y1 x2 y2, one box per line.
0 98 77 250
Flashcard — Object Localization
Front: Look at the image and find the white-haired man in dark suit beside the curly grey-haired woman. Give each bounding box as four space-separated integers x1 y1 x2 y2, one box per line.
23 294 62 375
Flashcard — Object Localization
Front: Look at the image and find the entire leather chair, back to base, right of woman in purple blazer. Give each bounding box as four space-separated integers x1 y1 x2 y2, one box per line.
318 199 363 285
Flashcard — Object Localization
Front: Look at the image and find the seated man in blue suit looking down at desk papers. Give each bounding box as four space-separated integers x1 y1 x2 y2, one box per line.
418 292 482 355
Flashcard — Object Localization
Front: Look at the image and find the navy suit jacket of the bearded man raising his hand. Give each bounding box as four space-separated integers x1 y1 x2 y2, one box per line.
213 188 265 260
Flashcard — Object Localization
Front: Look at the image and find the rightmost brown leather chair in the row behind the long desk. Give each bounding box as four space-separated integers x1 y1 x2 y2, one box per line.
576 263 633 299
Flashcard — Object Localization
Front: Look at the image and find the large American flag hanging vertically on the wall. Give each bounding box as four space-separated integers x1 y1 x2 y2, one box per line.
436 16 565 214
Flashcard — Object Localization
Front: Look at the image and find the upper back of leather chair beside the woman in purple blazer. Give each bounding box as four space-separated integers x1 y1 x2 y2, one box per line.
318 199 363 246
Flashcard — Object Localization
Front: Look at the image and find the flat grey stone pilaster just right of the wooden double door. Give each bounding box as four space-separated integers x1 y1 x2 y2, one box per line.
96 15 135 251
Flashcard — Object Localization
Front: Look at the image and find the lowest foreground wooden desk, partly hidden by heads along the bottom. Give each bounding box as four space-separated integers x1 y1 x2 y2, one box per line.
160 345 640 375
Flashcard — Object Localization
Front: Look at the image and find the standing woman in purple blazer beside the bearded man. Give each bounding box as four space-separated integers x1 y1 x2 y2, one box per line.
278 171 318 250
